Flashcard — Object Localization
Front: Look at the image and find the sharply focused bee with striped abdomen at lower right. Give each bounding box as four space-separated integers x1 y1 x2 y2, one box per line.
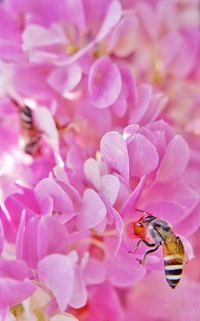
132 210 185 289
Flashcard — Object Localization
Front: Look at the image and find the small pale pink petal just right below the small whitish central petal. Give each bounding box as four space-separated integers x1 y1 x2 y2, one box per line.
99 174 120 206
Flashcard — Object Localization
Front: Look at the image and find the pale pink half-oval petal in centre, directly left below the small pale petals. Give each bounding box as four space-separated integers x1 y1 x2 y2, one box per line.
77 188 107 229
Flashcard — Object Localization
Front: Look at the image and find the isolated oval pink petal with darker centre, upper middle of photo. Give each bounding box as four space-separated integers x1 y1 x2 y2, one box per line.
88 57 122 108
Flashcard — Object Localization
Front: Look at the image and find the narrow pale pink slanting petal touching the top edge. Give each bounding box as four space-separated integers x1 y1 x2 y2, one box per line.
95 0 122 42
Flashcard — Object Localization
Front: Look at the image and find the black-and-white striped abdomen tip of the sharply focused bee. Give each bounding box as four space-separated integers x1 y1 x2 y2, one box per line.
164 254 183 289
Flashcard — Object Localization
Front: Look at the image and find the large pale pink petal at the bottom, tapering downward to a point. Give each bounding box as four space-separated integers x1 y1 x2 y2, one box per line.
38 254 74 311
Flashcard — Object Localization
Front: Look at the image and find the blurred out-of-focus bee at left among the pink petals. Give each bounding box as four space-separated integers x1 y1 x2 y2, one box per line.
12 99 41 156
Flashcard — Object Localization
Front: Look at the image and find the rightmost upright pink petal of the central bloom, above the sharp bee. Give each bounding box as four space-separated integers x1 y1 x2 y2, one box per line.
156 135 190 182
